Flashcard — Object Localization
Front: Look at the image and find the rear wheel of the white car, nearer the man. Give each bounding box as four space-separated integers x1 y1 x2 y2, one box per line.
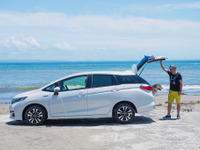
113 103 135 124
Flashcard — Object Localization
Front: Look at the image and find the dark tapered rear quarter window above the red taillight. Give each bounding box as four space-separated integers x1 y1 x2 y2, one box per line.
116 75 148 84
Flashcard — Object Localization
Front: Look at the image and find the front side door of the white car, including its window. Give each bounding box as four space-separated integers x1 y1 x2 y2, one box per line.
50 75 87 117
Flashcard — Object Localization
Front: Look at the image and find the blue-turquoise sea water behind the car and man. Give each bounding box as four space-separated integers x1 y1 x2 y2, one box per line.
0 60 200 103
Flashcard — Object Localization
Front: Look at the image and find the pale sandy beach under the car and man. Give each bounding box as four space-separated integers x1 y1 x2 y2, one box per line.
0 95 200 150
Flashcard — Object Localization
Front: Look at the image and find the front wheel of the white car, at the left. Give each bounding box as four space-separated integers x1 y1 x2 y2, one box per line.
24 105 47 125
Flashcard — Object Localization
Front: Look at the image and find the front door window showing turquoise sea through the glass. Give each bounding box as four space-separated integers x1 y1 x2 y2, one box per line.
60 75 87 91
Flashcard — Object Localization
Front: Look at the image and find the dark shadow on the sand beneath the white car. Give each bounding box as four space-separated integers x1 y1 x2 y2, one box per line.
6 116 155 127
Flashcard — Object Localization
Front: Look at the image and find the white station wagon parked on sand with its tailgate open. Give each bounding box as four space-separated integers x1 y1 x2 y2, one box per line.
10 56 166 125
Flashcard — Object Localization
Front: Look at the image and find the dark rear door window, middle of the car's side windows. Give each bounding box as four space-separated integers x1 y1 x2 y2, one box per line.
92 75 116 88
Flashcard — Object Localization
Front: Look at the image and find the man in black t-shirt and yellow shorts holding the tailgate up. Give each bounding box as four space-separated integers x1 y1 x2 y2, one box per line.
160 61 183 119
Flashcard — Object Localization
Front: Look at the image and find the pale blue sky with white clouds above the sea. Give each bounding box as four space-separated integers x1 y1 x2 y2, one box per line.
0 0 200 61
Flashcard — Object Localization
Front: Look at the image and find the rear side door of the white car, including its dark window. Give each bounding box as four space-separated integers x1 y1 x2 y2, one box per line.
87 75 120 115
